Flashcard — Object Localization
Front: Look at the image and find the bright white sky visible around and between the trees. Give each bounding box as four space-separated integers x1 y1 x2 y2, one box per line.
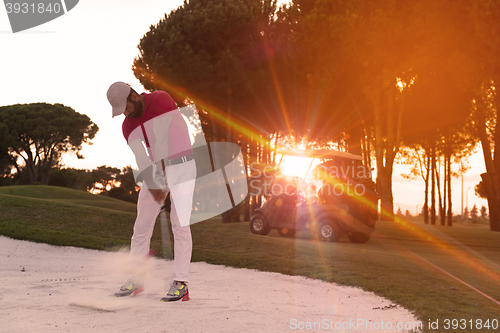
0 0 487 214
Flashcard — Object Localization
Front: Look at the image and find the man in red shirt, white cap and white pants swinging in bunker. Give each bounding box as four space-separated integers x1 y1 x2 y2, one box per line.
107 82 196 302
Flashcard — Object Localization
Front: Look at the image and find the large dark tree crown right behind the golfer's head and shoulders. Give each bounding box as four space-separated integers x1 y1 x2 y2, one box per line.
132 0 282 141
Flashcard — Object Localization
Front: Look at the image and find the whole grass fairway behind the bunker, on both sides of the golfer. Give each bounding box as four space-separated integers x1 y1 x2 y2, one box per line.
0 186 500 332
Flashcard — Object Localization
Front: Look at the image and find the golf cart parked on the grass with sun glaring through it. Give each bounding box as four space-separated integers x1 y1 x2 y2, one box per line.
250 150 379 243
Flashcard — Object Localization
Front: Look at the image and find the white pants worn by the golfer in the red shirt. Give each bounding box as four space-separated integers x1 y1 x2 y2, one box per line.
131 160 196 282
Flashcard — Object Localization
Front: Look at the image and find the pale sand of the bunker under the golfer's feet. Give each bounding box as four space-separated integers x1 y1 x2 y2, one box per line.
0 236 417 332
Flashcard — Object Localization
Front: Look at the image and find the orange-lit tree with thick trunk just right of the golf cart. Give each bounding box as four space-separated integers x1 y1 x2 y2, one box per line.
345 1 416 220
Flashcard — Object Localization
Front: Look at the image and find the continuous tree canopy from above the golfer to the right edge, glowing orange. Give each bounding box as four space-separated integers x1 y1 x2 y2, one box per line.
133 0 500 230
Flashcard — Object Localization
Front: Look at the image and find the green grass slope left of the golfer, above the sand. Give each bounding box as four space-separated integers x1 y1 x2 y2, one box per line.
0 190 135 250
